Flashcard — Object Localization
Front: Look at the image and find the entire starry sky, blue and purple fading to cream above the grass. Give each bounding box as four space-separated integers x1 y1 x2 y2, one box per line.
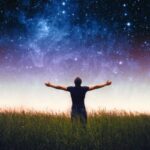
0 0 150 112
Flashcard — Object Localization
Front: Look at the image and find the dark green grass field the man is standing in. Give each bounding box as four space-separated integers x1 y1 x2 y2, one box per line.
0 111 150 150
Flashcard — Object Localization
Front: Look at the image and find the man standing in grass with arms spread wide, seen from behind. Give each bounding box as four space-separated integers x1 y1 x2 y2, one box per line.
45 77 112 125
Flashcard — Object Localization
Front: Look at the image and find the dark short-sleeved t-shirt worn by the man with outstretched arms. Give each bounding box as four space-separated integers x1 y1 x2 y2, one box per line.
67 86 89 108
